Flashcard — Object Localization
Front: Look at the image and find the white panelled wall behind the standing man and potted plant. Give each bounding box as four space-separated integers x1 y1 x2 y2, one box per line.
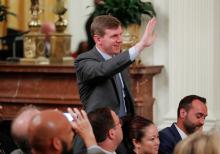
68 0 220 129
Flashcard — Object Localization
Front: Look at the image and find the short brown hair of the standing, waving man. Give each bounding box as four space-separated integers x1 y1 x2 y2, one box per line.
91 15 121 36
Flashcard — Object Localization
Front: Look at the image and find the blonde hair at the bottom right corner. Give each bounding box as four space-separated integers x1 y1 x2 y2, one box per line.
174 131 220 154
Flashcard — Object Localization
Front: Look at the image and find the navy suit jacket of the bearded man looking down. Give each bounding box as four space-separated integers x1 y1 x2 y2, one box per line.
159 123 182 154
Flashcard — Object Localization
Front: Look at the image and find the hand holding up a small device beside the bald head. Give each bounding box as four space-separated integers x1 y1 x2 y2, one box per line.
67 108 97 148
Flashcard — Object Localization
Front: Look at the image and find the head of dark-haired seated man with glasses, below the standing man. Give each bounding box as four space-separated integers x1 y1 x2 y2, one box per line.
88 107 123 154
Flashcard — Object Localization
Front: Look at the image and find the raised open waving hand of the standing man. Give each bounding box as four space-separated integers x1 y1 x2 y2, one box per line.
135 17 157 52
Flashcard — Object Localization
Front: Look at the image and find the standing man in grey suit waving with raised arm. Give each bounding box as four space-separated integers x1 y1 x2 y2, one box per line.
75 15 156 117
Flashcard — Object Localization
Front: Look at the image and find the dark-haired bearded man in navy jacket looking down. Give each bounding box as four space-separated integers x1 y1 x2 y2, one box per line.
159 95 208 154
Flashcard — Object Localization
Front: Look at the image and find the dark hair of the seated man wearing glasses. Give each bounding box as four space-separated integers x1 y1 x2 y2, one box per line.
88 107 114 143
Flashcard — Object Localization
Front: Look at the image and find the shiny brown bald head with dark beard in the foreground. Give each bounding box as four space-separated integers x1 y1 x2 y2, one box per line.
28 110 74 154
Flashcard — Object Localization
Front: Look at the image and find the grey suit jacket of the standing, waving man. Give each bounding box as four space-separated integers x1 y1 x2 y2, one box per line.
75 47 134 115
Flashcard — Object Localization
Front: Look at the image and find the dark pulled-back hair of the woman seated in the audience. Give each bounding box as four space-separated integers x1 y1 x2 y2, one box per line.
122 116 153 151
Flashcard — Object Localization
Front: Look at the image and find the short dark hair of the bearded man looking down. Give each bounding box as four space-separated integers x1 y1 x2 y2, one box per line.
177 95 206 117
